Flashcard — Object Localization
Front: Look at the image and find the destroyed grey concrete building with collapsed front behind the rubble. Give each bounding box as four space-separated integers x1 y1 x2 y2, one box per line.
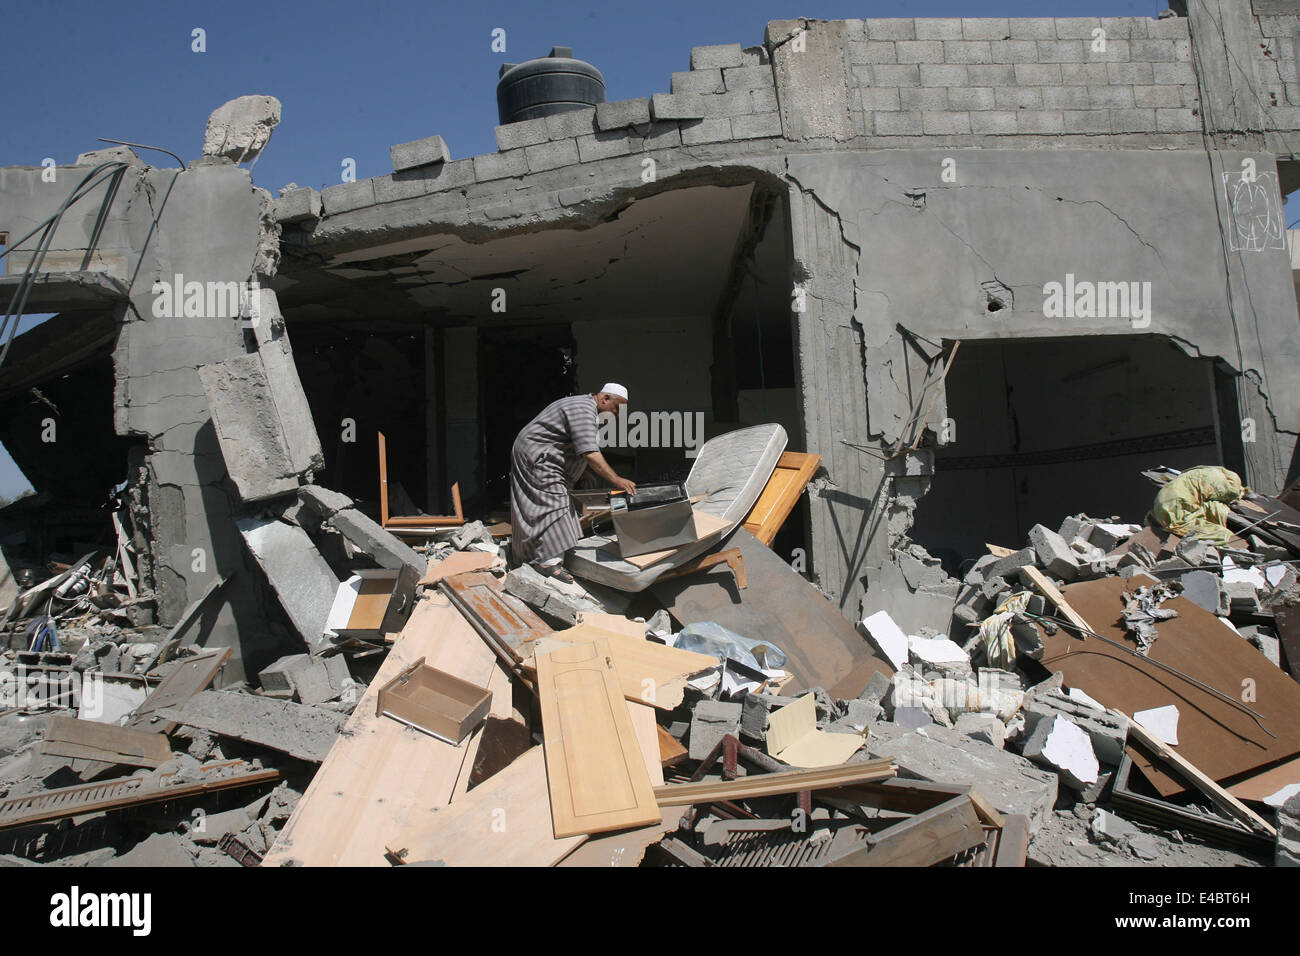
0 7 1300 862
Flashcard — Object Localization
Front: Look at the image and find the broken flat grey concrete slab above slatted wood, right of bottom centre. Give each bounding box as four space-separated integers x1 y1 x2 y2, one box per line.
849 723 1057 832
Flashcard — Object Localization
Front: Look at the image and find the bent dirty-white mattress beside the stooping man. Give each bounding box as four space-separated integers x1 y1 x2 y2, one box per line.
564 424 788 592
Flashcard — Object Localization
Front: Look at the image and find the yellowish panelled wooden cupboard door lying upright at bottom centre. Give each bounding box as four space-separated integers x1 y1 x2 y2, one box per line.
537 637 662 838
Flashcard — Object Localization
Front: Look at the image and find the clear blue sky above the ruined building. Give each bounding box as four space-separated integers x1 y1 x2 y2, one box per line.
0 0 1258 496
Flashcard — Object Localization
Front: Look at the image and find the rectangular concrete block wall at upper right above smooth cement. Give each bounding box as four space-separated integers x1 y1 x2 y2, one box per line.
845 17 1201 143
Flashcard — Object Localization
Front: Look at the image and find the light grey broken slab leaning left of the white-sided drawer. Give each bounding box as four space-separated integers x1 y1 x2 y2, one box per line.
235 518 340 649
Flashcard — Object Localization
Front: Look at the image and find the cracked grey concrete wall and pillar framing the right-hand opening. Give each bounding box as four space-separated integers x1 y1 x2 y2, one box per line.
788 150 1300 616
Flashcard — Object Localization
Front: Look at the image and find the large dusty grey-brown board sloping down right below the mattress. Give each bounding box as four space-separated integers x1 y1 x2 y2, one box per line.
650 528 893 697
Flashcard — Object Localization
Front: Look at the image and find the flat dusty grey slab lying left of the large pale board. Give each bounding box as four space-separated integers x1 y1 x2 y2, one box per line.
159 691 343 763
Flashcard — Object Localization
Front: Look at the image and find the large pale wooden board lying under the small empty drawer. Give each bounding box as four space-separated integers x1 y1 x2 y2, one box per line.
263 594 497 866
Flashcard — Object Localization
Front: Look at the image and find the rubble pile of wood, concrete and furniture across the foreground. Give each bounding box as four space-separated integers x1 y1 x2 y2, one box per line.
0 470 1300 866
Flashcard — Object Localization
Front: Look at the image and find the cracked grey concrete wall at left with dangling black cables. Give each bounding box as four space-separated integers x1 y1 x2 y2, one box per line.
0 160 318 680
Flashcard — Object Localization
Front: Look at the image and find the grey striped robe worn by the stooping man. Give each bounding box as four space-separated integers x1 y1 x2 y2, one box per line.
510 395 601 562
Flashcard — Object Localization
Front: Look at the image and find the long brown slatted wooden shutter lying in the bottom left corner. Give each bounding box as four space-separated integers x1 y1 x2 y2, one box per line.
0 761 280 829
